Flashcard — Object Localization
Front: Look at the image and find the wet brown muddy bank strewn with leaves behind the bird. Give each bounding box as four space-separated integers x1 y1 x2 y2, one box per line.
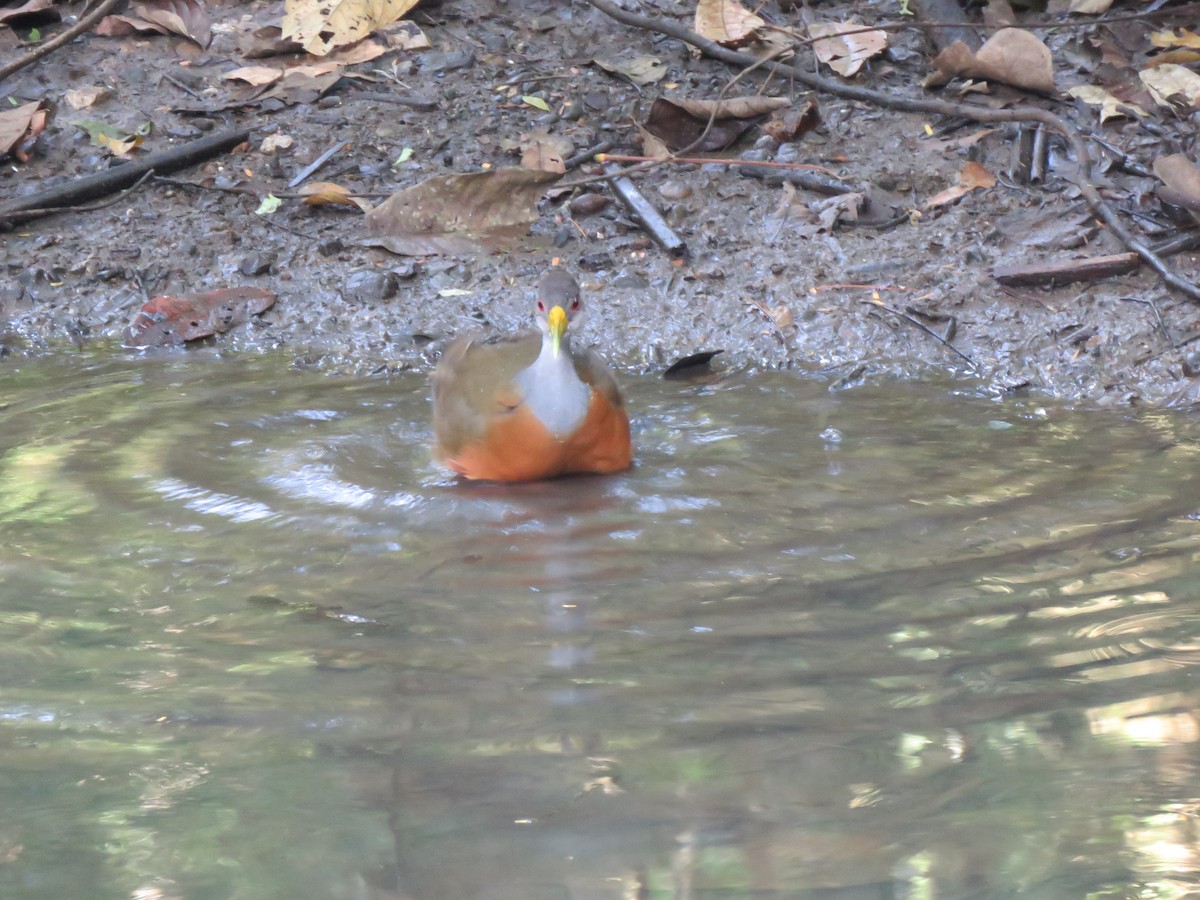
0 0 1200 404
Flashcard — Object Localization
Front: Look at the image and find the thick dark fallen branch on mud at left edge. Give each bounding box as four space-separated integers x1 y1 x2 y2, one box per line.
0 128 250 230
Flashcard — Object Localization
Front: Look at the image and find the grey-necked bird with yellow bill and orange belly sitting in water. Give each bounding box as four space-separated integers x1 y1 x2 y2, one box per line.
433 266 632 481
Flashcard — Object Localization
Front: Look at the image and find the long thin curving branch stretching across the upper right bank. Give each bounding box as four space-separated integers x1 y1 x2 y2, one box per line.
588 0 1200 300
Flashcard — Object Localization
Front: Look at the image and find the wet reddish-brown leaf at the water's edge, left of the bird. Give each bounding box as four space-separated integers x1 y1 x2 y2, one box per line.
125 288 275 347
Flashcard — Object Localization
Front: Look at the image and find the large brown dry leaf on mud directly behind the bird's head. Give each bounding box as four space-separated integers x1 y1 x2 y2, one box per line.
364 168 558 256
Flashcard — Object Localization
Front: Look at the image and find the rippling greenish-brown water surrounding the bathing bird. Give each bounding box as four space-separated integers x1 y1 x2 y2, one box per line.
0 354 1200 900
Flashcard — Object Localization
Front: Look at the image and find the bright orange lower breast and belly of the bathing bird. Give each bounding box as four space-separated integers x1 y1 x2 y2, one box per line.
443 391 634 481
